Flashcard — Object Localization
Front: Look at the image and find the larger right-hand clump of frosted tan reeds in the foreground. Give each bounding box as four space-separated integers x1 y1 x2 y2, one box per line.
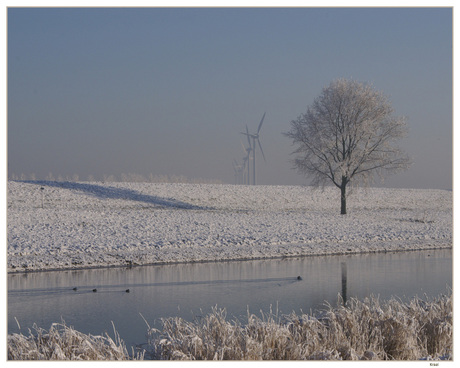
149 295 453 360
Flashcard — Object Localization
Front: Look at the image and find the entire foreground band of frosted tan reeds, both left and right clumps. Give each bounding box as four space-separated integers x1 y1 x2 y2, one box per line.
8 292 453 361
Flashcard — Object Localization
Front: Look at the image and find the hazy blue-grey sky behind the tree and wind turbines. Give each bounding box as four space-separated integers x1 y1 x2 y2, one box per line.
7 8 452 189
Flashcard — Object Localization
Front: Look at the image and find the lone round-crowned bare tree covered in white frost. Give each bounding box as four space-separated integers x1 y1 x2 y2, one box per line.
284 79 410 214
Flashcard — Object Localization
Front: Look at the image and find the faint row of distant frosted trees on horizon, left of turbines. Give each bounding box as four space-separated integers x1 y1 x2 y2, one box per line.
8 173 223 184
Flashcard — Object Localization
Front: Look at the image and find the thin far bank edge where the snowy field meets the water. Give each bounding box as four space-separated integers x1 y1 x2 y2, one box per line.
7 240 453 275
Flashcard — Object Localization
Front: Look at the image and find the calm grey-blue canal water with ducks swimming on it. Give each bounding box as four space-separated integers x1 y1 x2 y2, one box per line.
8 250 452 351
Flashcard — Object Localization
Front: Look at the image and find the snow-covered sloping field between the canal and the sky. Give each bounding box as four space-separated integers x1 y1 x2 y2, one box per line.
7 181 452 272
